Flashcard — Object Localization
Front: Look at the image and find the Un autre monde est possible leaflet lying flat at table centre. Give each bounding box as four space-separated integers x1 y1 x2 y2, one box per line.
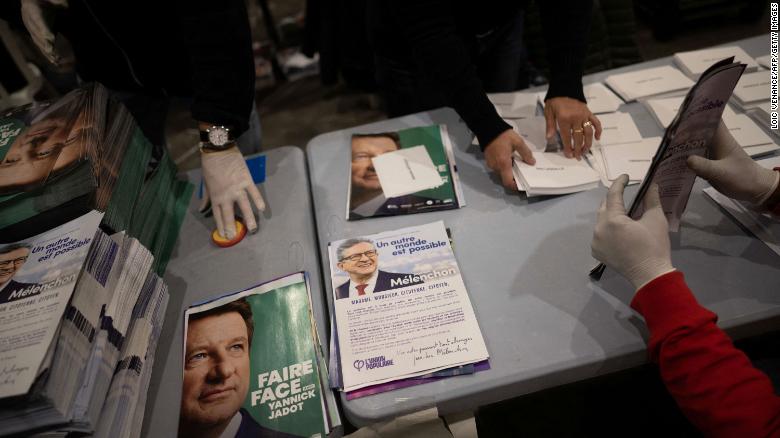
329 221 488 391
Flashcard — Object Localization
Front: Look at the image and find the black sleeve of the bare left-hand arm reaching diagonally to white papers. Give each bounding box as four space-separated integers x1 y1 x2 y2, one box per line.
391 0 510 149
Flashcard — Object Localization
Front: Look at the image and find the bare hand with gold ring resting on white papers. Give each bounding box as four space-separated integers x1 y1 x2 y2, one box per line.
544 97 601 160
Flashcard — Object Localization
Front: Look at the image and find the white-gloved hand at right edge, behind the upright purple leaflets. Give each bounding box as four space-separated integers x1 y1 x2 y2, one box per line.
688 120 780 206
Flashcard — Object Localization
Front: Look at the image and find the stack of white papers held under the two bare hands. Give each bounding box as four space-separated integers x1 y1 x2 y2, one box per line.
512 152 600 197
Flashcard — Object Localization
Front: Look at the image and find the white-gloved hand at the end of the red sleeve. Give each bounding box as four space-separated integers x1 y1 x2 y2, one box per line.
590 174 674 289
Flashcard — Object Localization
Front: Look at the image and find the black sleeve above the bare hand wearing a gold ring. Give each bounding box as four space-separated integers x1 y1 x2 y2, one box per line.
539 0 593 102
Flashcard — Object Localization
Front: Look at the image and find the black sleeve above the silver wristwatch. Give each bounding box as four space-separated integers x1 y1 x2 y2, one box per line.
177 0 255 136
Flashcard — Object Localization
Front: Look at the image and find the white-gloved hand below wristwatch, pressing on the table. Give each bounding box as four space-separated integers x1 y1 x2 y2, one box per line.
200 146 265 239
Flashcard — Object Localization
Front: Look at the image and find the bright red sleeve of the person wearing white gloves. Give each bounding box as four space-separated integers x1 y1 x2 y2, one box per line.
631 271 780 438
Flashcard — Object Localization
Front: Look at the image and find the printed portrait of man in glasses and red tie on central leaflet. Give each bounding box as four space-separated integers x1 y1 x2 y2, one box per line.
336 238 422 300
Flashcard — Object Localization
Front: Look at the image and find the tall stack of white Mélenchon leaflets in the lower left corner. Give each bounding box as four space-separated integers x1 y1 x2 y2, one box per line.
0 211 168 437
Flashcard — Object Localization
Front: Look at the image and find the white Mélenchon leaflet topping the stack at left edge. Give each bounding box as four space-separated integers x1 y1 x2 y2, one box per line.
0 211 103 398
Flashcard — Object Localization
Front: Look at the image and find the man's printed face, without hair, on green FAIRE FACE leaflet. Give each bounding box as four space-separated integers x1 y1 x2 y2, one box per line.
181 312 249 426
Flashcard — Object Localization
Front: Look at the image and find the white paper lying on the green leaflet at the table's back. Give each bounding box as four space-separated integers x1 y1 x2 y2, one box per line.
371 146 444 198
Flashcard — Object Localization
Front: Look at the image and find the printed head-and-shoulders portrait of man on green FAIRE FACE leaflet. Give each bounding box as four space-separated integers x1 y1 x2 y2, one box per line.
179 298 294 438
